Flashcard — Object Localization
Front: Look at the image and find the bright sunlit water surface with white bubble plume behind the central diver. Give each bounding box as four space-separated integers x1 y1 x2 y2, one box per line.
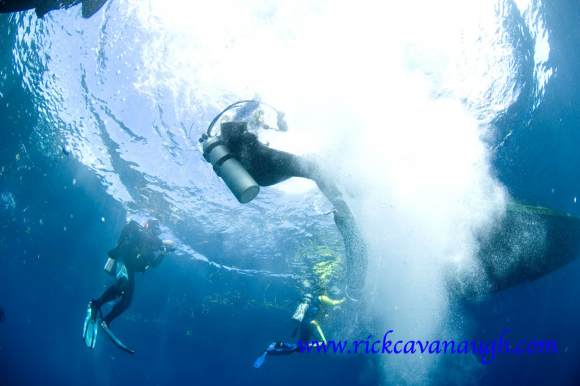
9 0 553 384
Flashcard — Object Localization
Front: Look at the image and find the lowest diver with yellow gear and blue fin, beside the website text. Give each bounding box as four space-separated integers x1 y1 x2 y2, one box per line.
253 247 347 369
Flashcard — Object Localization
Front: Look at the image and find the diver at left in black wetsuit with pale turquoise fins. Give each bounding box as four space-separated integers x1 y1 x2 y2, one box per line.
83 220 173 353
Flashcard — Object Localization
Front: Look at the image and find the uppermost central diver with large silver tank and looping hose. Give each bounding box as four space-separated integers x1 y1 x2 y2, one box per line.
200 100 367 300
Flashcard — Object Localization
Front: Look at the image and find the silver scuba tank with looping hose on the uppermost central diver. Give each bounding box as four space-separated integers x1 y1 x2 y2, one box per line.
199 100 287 204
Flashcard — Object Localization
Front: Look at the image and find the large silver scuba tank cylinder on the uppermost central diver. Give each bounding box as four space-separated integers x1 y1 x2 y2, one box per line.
203 136 260 204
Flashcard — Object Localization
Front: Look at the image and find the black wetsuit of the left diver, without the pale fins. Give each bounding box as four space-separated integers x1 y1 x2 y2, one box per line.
93 221 163 325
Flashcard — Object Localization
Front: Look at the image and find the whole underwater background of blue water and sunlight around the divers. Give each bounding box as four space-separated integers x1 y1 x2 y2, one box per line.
0 0 580 386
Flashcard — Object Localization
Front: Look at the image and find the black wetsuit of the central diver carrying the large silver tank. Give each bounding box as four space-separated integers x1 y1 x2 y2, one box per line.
221 122 367 290
